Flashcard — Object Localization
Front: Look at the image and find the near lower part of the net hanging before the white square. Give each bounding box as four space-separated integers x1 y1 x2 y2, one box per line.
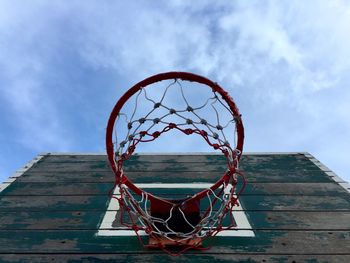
120 176 241 244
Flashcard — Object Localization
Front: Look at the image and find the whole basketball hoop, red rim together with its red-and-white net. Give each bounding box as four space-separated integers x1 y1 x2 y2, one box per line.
106 72 245 255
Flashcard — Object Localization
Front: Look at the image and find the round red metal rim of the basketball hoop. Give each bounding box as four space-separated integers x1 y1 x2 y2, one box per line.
106 72 244 198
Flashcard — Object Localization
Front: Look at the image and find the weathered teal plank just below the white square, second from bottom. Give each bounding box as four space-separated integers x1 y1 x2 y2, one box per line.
0 230 350 255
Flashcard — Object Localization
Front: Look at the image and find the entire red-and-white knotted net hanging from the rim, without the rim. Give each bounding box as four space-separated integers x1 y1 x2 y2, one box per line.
108 76 245 252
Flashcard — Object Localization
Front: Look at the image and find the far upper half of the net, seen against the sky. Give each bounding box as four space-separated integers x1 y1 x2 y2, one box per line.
114 79 240 164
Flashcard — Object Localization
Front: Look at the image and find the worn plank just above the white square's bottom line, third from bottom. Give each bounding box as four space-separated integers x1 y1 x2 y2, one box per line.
0 210 350 231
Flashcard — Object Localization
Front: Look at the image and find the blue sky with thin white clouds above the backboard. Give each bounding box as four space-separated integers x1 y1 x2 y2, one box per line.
0 0 350 184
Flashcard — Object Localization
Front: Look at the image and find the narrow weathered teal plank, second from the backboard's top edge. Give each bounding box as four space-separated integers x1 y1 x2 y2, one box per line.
32 155 319 173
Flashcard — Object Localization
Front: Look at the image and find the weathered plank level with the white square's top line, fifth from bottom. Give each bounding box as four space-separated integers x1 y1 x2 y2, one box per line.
2 181 346 196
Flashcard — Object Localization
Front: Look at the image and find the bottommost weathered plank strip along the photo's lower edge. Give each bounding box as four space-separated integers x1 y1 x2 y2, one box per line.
0 256 350 263
